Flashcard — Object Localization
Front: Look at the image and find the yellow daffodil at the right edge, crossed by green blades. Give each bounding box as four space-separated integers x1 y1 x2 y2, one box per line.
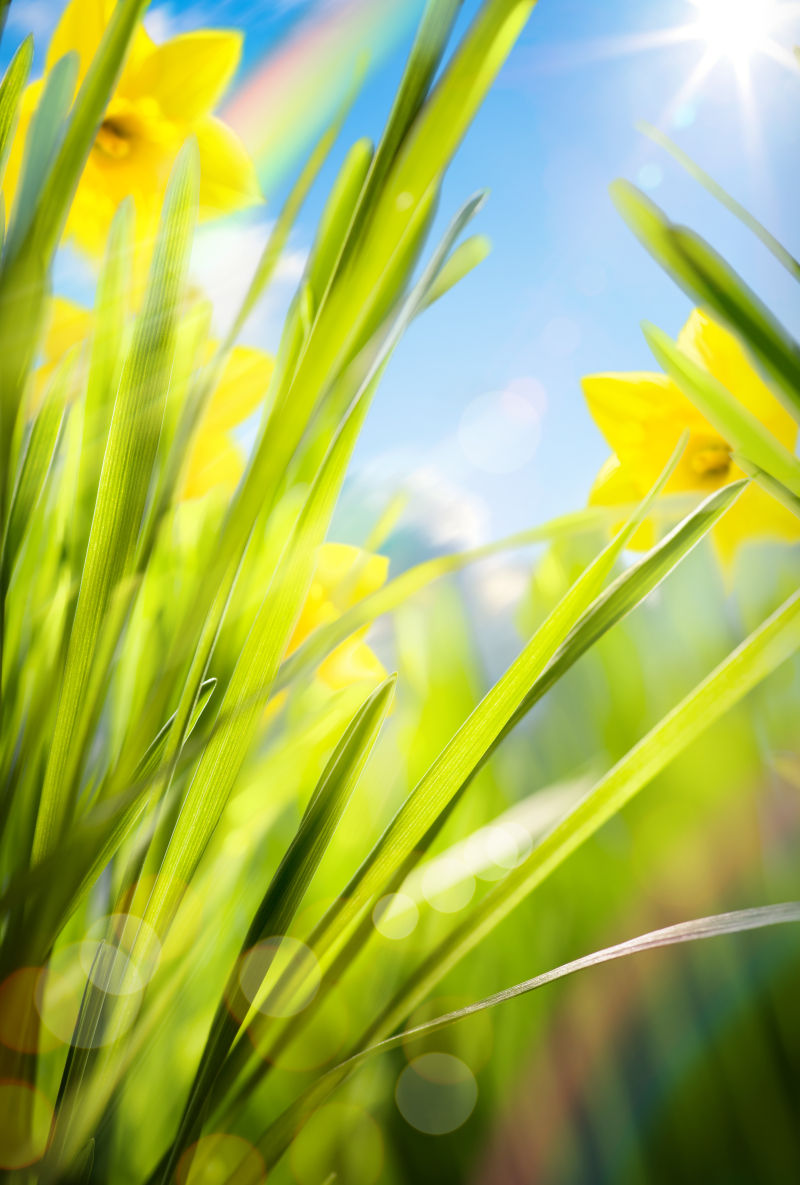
583 309 800 566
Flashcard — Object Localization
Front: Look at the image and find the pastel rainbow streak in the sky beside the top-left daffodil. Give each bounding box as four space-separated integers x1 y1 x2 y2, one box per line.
223 0 422 196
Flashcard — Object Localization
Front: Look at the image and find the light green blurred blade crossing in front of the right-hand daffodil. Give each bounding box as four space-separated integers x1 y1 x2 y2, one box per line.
645 325 800 494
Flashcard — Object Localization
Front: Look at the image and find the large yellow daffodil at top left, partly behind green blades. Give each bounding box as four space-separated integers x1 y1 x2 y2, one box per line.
4 0 261 256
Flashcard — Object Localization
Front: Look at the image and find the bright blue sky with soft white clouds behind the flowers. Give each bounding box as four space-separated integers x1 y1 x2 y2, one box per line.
5 0 800 538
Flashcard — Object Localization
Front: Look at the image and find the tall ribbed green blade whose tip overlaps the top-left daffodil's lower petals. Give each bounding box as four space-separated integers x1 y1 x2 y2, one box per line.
33 145 198 860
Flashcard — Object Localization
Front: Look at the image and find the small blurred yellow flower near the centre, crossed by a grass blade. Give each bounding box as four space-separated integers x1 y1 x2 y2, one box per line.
287 543 389 691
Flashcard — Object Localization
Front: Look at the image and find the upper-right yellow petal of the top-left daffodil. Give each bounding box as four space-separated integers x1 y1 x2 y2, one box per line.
124 28 242 126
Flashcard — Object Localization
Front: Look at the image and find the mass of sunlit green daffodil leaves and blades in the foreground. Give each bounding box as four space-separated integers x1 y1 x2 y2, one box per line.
0 0 800 1185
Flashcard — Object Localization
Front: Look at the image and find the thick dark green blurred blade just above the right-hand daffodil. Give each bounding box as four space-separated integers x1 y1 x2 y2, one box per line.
612 181 800 418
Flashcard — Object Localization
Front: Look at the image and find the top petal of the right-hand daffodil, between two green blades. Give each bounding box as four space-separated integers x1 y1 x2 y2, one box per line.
678 309 798 449
